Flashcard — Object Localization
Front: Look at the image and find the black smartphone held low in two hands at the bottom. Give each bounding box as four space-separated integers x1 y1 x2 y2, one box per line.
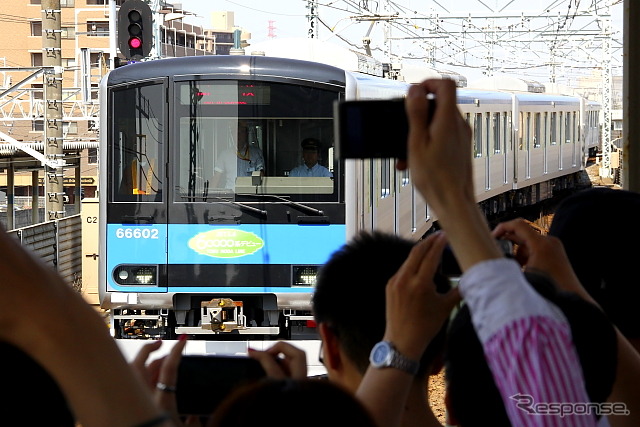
176 355 266 416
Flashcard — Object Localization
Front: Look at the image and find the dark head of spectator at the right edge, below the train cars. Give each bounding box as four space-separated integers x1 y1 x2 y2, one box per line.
549 187 640 338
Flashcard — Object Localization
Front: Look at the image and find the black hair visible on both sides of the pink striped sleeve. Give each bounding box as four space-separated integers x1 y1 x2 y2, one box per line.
444 272 618 427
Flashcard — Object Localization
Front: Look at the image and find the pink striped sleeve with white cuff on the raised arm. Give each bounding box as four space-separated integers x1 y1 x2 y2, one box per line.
459 258 598 427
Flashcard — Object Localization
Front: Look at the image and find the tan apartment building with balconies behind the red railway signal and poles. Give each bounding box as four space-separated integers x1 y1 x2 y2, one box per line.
0 0 250 212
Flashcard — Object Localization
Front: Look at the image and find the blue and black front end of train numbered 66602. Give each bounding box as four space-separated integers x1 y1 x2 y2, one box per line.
100 56 346 340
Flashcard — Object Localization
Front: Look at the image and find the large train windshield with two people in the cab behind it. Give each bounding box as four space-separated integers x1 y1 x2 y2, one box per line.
173 80 339 202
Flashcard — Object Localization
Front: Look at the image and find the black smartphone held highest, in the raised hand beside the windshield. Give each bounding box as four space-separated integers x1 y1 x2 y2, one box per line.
334 98 409 159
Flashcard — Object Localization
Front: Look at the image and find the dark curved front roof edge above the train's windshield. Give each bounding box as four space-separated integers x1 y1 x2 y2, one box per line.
107 55 346 86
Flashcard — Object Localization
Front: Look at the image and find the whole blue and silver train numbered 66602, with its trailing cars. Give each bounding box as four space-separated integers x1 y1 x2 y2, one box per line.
99 40 598 340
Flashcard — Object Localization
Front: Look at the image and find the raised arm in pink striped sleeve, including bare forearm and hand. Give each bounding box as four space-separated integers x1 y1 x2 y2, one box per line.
399 80 595 425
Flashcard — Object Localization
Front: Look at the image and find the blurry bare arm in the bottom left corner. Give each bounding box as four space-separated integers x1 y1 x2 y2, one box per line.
0 229 172 427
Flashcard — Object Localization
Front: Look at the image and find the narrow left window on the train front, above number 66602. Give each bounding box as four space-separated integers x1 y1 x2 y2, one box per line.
109 84 166 202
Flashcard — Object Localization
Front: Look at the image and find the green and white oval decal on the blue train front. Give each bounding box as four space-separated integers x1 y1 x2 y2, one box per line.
189 228 264 258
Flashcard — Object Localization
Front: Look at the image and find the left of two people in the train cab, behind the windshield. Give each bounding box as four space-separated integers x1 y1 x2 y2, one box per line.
212 121 264 188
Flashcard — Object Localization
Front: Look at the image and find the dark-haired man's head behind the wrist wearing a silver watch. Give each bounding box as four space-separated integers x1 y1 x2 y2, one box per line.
313 232 449 389
